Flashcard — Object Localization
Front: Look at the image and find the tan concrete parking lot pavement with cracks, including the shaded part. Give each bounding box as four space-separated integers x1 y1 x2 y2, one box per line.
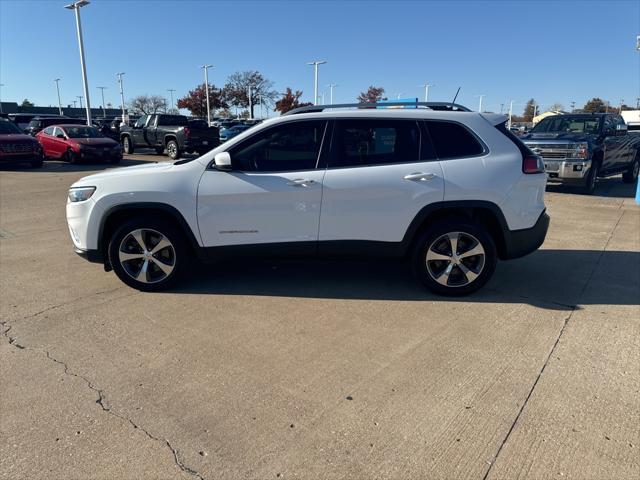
0 154 640 480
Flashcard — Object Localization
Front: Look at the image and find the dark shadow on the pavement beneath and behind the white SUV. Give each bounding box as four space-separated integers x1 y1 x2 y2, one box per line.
172 250 640 310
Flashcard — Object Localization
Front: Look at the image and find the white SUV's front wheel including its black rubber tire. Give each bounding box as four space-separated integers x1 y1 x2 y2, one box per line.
109 216 189 292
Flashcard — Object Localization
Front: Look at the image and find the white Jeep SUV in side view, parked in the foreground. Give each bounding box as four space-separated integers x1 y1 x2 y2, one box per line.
67 103 549 295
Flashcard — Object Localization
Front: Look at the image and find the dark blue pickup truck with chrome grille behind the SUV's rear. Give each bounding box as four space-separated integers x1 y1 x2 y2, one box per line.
520 113 640 194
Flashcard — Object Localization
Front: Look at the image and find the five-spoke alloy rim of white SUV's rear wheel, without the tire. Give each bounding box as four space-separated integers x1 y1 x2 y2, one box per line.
425 232 486 287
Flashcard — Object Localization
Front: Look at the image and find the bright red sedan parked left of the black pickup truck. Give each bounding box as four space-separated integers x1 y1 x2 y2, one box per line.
36 125 122 163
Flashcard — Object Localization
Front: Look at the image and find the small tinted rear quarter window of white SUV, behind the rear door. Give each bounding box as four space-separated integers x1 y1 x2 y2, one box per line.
425 120 485 160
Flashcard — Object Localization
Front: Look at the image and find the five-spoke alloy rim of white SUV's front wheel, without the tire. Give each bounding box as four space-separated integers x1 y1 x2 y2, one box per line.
118 228 176 283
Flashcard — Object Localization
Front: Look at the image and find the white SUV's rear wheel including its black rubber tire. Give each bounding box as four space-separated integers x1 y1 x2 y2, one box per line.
411 219 498 296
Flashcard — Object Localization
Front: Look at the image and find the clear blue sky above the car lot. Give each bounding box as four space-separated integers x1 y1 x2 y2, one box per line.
0 0 640 115
